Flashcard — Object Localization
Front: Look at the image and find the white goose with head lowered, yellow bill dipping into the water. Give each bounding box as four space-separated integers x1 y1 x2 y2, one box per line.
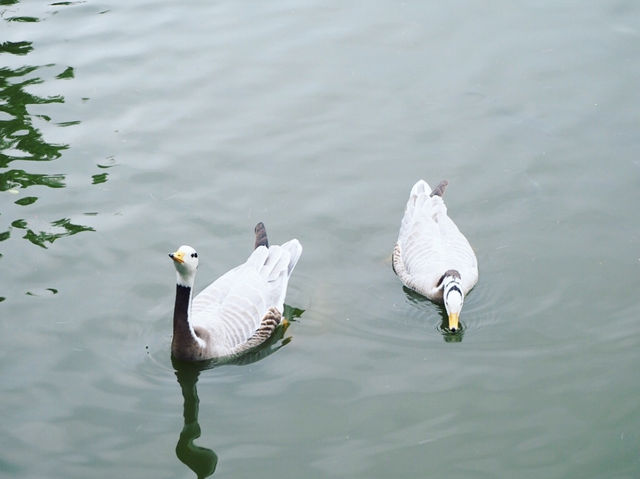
392 180 478 332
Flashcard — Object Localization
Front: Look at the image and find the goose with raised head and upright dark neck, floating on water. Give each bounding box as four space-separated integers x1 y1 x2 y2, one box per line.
169 223 302 361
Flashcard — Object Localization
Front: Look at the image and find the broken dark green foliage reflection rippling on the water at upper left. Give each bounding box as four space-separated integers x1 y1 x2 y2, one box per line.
0 1 98 300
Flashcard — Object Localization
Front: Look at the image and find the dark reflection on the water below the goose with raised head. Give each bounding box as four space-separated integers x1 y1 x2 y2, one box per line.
171 304 304 479
